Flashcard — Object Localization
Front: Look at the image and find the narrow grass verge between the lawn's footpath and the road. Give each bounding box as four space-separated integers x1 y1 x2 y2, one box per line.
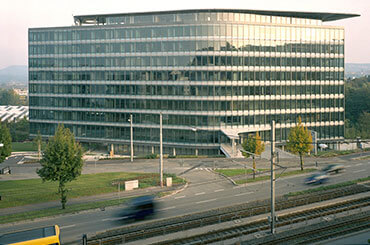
0 198 129 224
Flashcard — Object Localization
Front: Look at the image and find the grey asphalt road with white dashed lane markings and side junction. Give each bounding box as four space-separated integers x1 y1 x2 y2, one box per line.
0 155 370 242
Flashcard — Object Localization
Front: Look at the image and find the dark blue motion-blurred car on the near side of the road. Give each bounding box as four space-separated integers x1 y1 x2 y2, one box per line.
119 196 157 220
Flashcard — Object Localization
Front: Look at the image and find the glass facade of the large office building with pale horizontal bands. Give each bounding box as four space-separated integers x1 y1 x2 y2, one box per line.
29 11 344 155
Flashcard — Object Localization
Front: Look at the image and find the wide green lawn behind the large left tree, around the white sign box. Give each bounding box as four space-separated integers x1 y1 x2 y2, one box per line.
0 172 184 208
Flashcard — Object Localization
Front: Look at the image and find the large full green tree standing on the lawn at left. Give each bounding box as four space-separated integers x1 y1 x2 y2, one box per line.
37 125 83 209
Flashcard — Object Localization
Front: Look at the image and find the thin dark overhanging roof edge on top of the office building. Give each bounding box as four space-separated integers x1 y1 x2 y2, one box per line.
74 9 360 21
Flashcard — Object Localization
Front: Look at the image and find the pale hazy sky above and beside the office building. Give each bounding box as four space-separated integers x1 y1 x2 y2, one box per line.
0 0 370 69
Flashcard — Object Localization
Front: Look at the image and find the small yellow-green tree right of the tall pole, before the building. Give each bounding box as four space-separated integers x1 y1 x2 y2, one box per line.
287 117 313 170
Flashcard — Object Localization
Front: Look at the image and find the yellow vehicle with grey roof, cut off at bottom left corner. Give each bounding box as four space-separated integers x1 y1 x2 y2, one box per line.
0 225 60 245
